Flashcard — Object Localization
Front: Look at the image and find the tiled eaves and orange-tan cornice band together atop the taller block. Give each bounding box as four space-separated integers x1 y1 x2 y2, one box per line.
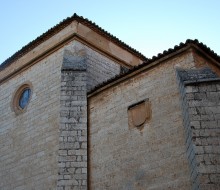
0 15 147 84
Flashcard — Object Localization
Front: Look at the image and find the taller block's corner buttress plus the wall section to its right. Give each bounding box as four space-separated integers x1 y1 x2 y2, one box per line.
57 41 120 190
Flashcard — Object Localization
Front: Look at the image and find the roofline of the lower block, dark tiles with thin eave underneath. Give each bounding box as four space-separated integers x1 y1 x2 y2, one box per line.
87 39 220 98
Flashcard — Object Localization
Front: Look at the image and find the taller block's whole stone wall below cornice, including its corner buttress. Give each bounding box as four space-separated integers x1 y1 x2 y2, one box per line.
0 41 121 190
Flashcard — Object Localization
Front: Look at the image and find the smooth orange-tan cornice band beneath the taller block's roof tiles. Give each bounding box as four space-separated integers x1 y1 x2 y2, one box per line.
0 20 144 84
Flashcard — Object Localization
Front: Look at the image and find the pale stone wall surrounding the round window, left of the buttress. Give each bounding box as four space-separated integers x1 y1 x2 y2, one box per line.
0 51 63 190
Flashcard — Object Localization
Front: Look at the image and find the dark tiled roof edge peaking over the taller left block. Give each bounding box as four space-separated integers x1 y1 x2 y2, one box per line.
0 13 147 70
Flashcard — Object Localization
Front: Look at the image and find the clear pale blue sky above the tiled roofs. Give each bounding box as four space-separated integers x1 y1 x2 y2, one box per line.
0 0 220 63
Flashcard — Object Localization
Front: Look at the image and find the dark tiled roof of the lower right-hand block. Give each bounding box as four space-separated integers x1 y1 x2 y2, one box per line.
87 39 220 96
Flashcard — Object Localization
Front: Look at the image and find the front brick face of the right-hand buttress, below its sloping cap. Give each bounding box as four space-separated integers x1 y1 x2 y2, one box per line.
186 80 220 190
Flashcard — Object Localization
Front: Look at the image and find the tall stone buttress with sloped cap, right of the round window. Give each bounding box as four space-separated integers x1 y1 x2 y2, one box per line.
57 51 87 190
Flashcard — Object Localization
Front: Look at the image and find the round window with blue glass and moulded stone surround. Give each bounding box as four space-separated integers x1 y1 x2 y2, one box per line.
12 82 32 114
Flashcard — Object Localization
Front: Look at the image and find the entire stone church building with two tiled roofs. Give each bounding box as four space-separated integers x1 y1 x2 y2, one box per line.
0 14 220 190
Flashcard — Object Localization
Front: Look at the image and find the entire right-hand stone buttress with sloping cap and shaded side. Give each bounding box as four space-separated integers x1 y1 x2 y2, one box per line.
178 68 220 190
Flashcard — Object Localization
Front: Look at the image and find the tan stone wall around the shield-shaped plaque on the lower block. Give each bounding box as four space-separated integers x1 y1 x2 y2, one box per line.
88 52 194 190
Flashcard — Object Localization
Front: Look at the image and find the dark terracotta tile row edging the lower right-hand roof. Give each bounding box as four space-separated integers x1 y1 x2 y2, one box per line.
87 39 220 94
